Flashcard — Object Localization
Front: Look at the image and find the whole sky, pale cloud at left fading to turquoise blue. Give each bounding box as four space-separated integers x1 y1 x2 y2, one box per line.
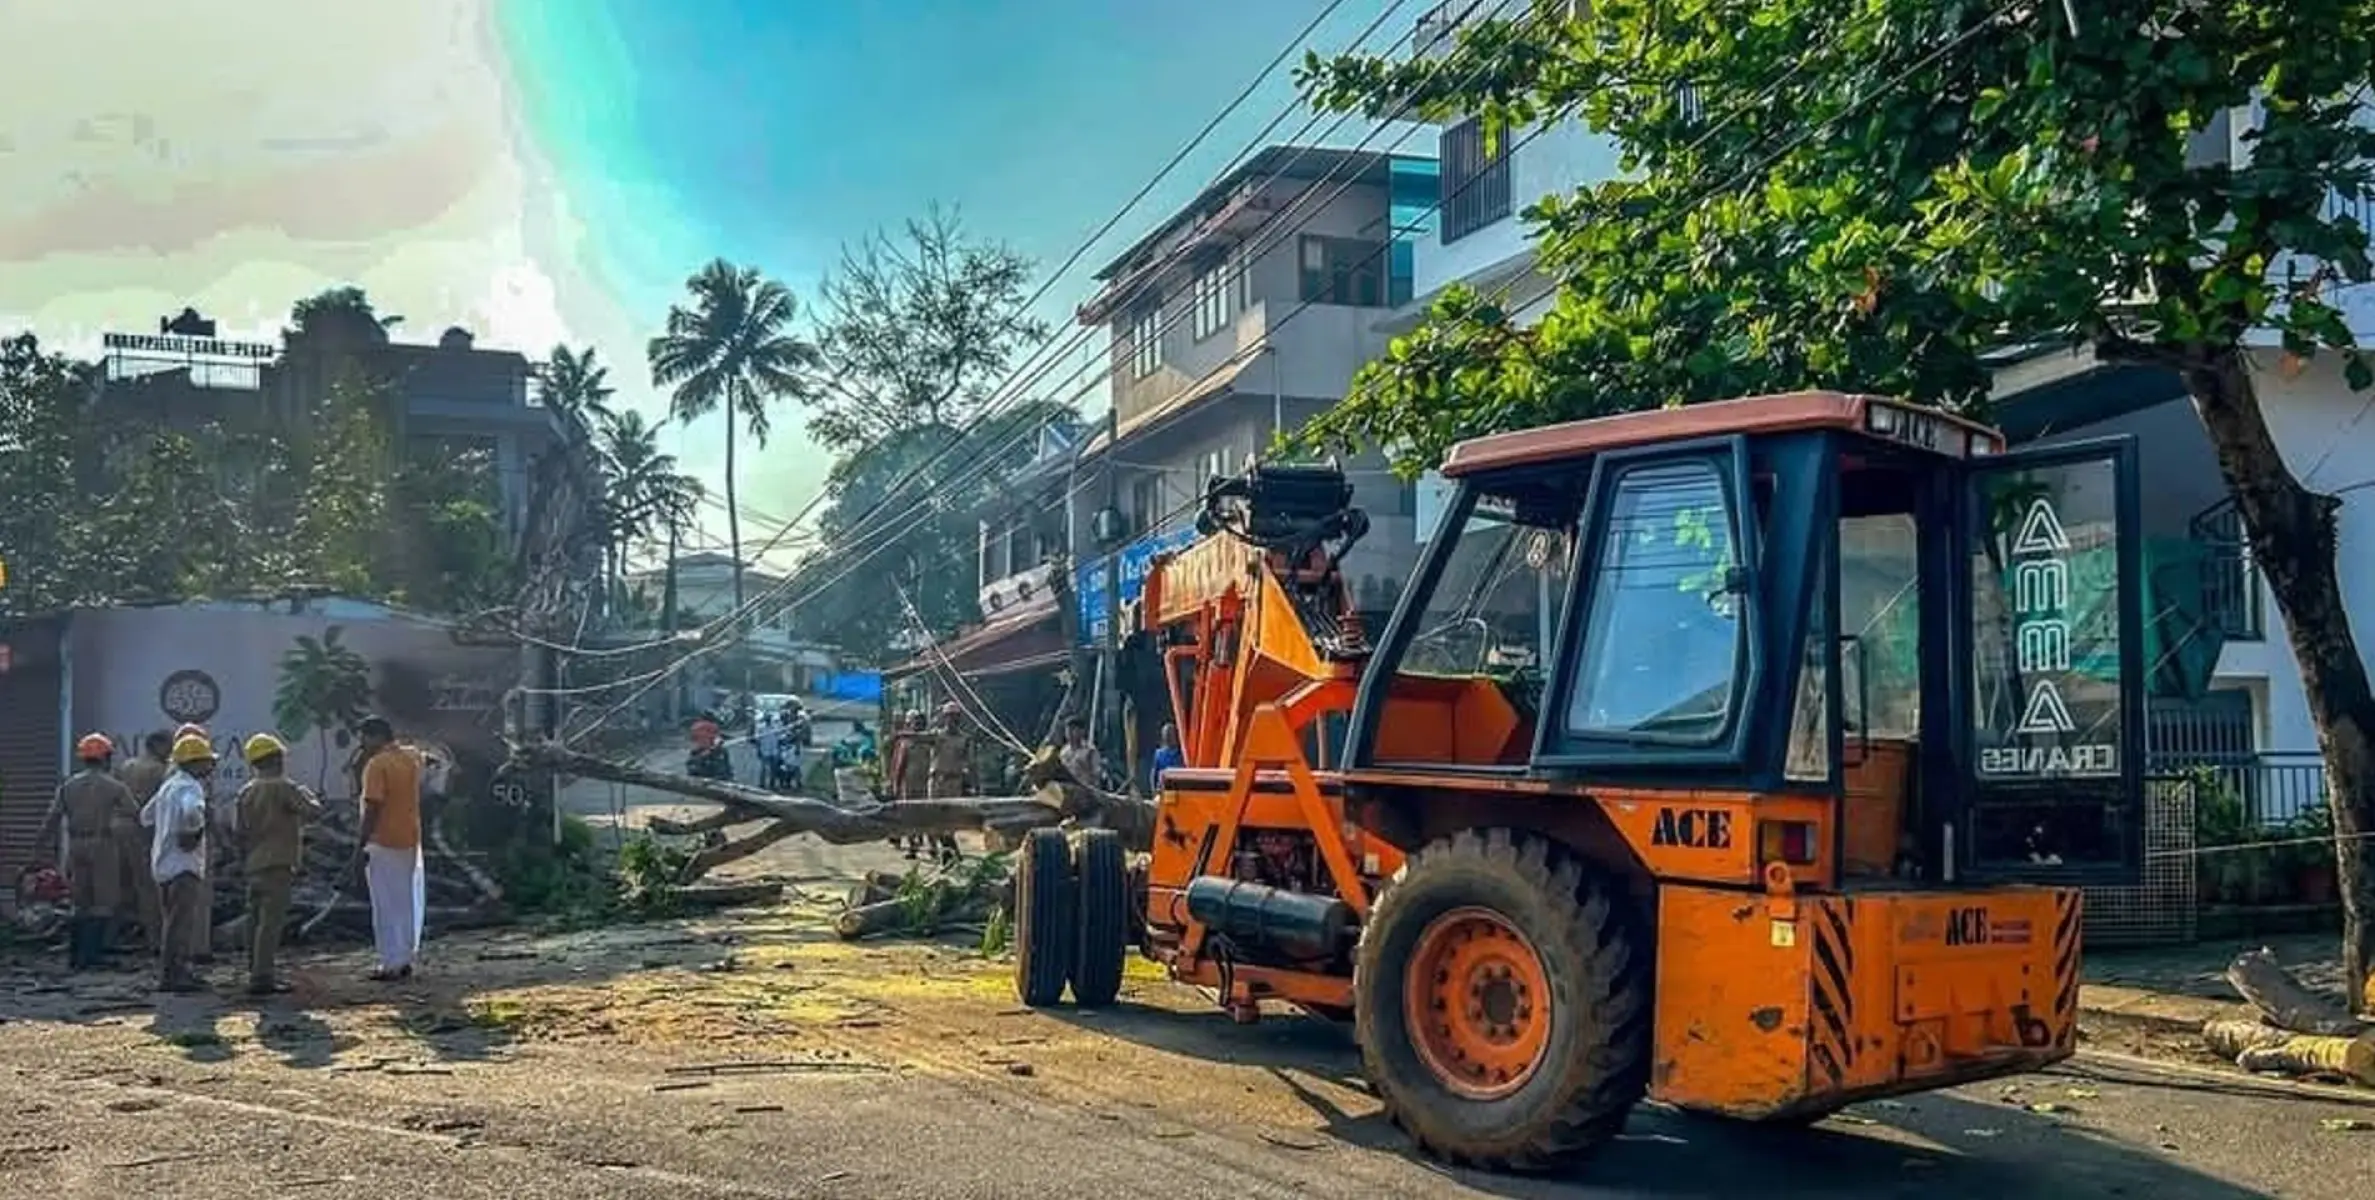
0 0 1420 565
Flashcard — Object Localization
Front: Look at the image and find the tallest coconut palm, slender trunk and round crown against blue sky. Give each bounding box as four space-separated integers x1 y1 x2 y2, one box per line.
646 259 819 613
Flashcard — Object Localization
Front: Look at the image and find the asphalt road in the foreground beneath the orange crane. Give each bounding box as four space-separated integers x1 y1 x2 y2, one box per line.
0 979 2375 1200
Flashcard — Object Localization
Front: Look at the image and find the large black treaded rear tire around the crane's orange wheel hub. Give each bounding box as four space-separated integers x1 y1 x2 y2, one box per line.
1354 829 1653 1171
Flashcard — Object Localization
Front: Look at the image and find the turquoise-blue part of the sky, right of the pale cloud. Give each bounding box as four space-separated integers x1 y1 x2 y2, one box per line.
501 0 1401 551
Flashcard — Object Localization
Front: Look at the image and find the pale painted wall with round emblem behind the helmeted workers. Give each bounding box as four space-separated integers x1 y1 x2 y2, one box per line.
67 604 520 798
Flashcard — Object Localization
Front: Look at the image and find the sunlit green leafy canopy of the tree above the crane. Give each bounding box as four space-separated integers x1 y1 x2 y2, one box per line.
1302 0 2375 470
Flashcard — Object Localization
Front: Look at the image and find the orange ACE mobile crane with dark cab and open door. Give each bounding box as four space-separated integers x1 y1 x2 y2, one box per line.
1017 392 2145 1169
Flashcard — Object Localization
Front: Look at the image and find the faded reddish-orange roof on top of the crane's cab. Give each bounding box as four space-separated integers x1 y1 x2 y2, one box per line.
1444 392 2005 475
